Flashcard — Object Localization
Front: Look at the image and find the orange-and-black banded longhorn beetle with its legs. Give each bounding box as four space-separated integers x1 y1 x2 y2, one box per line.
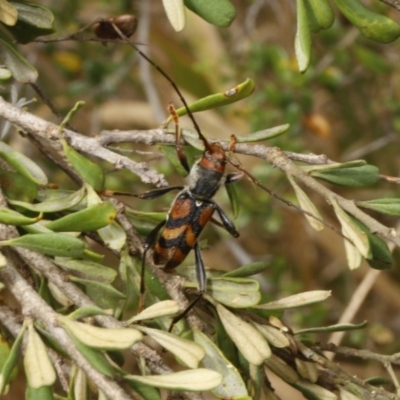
137 105 242 321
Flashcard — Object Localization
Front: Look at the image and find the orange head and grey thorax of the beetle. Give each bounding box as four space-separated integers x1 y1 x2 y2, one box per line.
188 143 227 199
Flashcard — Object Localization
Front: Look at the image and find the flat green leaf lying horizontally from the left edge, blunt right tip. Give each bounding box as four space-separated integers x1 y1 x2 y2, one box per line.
0 233 85 258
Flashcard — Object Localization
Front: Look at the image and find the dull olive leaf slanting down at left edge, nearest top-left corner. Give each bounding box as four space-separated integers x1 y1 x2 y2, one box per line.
0 30 38 83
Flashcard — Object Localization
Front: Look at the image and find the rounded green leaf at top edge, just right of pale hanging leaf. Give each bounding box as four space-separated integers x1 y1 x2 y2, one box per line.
184 0 236 28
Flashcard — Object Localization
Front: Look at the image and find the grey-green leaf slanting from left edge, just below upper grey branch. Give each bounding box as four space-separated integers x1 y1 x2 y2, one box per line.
0 141 48 185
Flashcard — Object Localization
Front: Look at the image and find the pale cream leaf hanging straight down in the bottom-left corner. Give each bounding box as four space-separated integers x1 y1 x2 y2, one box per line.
24 323 56 389
